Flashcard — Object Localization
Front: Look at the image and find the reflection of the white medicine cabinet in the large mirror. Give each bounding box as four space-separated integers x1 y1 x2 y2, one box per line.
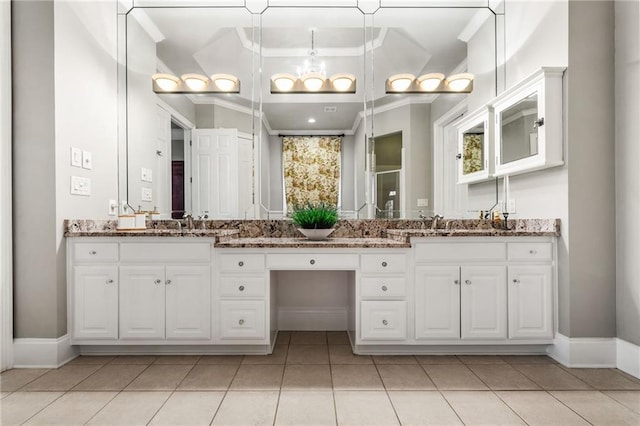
456 107 494 183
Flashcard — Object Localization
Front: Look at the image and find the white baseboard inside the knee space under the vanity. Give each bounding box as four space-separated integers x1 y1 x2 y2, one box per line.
278 307 348 331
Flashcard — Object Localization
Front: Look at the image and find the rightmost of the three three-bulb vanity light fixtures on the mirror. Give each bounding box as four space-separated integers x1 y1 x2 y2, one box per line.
385 72 473 94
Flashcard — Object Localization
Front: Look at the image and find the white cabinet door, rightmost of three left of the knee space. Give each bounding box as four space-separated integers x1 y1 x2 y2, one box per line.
165 266 211 339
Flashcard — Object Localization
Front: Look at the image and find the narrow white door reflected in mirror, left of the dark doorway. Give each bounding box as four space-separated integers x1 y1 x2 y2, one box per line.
156 105 171 217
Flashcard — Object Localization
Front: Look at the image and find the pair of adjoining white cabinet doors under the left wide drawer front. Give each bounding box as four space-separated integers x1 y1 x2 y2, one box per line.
120 265 211 340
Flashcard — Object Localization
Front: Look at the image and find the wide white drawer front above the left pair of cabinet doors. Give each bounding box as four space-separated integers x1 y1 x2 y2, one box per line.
120 240 211 263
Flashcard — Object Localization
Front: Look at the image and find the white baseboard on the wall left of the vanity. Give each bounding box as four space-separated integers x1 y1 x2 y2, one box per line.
13 334 79 368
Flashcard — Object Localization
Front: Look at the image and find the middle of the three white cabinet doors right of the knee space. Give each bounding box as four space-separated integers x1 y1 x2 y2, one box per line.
460 266 507 339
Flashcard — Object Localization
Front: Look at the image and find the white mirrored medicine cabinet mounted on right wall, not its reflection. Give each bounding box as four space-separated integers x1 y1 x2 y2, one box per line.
489 67 564 176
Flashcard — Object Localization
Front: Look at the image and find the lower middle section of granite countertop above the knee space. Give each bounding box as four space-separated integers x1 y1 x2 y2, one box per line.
216 237 411 248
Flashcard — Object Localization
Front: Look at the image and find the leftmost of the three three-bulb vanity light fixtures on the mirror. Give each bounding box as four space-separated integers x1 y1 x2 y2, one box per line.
151 73 240 94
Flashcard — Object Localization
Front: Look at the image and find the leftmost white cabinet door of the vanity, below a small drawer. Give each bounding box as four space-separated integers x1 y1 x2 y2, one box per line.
72 266 118 340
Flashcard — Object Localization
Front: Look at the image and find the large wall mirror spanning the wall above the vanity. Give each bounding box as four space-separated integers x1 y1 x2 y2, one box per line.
119 1 496 219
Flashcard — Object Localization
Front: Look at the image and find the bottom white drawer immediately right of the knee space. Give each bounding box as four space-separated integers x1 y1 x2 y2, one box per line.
360 301 407 340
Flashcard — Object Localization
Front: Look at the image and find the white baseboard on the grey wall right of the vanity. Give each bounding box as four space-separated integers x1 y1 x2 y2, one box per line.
547 334 618 368
